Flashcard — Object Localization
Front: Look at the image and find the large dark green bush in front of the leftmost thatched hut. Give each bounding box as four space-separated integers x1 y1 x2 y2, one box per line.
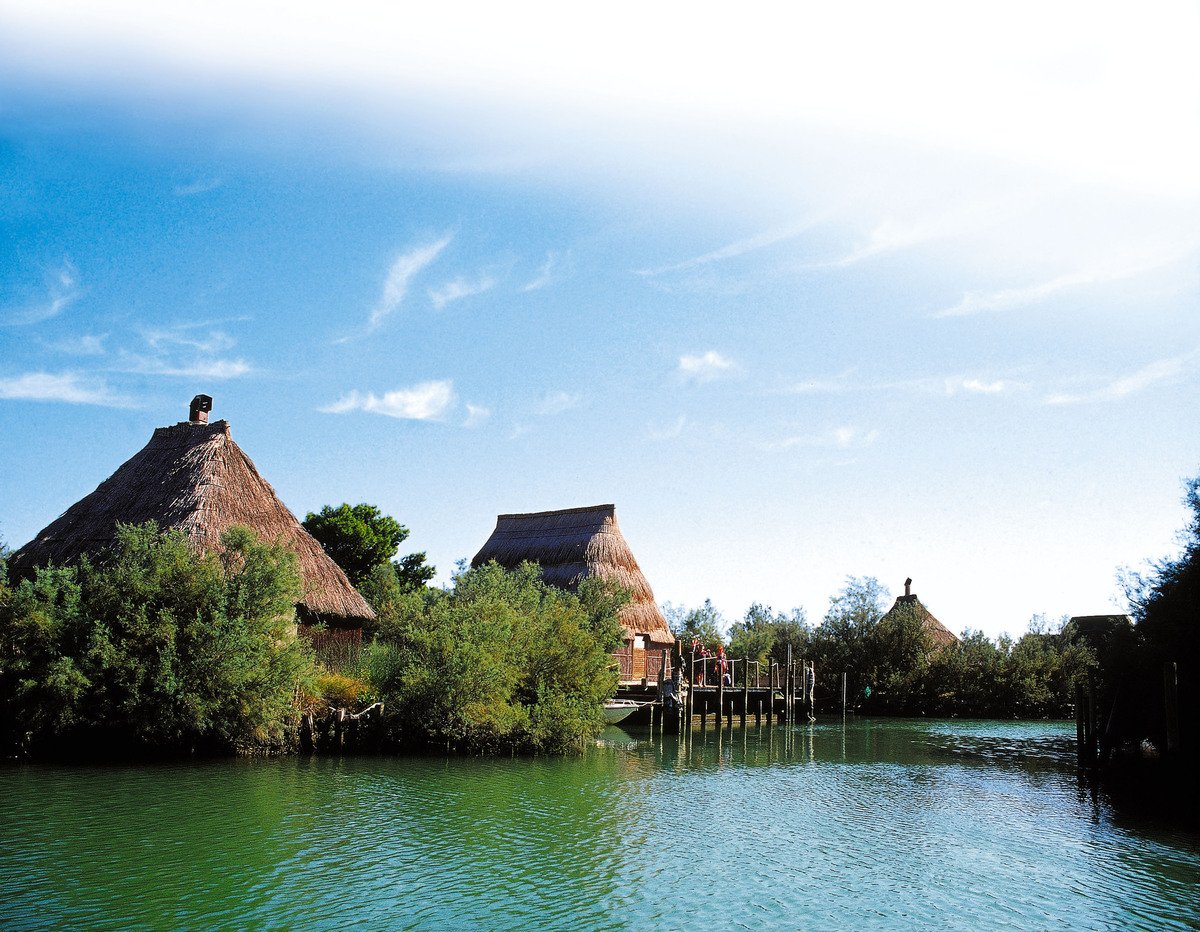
0 523 314 757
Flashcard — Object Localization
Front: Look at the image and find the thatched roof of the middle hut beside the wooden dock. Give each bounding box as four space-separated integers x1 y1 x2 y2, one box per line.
470 505 674 644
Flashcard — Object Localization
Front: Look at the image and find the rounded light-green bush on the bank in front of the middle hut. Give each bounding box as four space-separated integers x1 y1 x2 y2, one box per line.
362 563 629 751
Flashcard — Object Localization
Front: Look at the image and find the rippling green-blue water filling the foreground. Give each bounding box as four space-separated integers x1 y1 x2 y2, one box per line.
0 721 1200 932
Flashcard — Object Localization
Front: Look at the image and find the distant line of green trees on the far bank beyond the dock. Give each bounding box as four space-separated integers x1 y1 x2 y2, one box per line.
671 577 1094 717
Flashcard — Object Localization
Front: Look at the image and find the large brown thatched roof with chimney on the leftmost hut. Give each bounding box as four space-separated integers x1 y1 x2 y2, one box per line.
8 395 374 627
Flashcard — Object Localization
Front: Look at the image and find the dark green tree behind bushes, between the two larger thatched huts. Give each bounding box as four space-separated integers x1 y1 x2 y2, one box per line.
302 503 437 590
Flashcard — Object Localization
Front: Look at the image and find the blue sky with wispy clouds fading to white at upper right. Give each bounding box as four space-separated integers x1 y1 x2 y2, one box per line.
0 0 1200 637
